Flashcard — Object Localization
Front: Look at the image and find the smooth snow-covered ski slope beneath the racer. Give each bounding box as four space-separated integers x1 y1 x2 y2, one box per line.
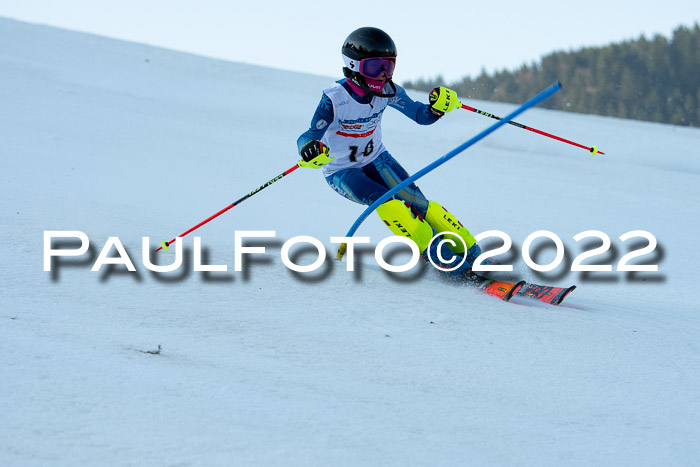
0 19 700 466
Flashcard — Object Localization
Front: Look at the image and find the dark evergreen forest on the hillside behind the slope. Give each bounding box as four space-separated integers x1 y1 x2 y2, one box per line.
404 24 700 127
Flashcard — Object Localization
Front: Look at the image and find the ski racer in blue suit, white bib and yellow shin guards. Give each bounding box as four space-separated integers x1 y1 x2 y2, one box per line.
297 27 481 276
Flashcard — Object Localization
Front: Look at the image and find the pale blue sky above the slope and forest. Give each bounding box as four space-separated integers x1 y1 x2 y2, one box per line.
0 0 700 82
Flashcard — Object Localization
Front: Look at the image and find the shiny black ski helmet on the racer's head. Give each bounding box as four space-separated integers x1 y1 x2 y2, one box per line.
341 27 396 97
